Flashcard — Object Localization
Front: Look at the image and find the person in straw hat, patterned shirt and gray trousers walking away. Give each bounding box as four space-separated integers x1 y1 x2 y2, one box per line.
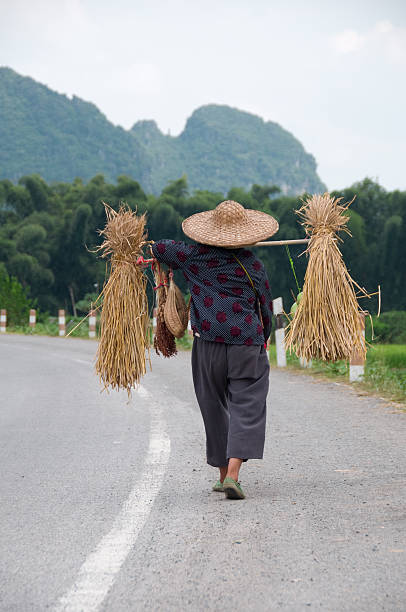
152 200 278 499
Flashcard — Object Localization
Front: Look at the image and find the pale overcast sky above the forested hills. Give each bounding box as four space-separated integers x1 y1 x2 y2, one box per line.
0 0 406 190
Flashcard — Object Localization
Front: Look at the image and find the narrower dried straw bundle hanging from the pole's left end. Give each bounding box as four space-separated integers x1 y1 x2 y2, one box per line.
96 202 149 394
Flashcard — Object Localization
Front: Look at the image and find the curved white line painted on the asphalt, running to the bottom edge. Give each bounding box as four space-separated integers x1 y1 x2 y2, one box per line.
55 385 171 612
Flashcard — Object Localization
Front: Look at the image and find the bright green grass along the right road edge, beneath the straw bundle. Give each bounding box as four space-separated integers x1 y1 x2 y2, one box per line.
269 344 406 404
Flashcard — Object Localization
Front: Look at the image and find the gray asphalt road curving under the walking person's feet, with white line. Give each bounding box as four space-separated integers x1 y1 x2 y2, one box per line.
0 335 406 612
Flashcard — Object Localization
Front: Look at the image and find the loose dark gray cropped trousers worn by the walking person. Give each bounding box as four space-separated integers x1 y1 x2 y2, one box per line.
192 337 269 467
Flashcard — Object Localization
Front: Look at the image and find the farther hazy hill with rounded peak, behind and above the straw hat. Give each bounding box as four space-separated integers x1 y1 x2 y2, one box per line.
132 104 325 194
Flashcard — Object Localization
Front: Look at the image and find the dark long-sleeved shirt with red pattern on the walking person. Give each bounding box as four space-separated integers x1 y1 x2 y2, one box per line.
152 240 272 346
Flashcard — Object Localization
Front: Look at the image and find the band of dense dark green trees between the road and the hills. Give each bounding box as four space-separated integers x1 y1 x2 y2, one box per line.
0 175 406 313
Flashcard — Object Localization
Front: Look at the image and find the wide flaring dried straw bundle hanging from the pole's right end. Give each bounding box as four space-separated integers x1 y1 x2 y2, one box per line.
286 193 369 361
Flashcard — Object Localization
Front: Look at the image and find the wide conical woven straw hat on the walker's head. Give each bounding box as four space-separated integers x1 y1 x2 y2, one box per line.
182 200 279 247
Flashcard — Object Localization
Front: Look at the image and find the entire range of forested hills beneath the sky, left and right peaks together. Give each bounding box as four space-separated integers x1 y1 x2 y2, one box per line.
0 67 325 194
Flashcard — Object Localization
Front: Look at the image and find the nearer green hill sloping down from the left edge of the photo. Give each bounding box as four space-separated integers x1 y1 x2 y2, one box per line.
0 68 147 181
